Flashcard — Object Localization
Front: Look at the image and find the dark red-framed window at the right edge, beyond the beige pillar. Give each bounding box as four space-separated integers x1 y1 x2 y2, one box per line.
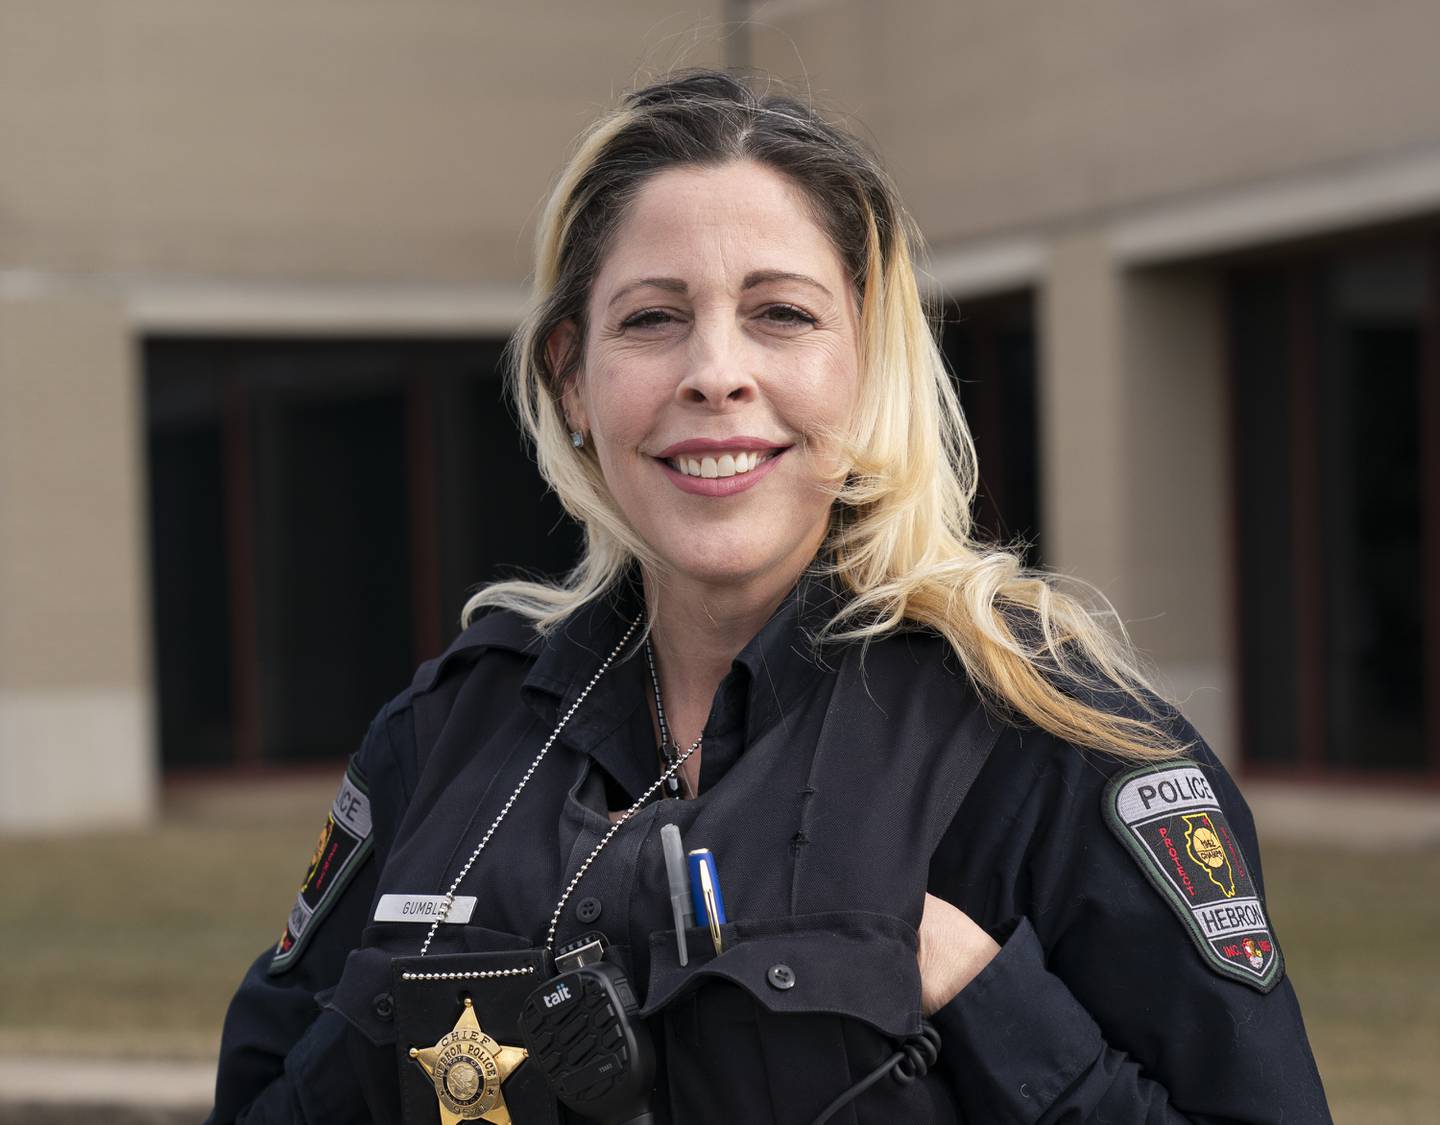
1228 239 1440 774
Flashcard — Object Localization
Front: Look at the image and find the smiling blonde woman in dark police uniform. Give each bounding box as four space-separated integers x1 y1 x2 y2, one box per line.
213 72 1328 1125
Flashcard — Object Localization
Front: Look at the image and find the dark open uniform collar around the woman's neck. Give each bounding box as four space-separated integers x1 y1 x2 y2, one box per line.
521 570 840 792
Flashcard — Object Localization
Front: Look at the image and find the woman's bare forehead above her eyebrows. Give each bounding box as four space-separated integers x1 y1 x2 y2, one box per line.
595 161 844 302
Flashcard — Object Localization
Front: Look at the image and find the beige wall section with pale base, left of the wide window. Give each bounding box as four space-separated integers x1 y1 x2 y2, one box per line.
0 297 157 830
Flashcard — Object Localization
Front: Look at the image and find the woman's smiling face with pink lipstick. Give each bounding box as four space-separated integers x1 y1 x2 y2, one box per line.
566 161 860 596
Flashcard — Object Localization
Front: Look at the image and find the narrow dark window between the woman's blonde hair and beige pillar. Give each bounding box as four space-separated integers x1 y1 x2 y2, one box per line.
940 292 1041 565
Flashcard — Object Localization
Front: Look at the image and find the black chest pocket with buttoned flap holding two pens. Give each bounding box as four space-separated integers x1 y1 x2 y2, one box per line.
642 910 956 1125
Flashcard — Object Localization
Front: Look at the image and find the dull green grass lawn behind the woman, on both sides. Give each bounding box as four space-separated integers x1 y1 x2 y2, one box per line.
0 784 1440 1125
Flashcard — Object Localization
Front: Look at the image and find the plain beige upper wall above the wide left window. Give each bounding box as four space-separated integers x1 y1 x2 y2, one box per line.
0 0 719 285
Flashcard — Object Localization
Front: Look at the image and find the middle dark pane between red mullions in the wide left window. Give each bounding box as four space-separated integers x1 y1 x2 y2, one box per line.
250 385 420 762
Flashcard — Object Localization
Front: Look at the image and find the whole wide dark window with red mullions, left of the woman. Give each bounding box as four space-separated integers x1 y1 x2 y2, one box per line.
144 339 579 766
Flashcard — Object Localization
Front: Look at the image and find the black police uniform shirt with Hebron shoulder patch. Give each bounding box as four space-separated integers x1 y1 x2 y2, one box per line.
210 581 1329 1125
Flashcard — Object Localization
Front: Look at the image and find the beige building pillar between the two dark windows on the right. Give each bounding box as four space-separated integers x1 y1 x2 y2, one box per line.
1038 241 1238 759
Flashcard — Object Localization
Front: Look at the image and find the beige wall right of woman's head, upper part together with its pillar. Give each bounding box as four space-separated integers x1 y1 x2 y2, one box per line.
756 0 1440 759
